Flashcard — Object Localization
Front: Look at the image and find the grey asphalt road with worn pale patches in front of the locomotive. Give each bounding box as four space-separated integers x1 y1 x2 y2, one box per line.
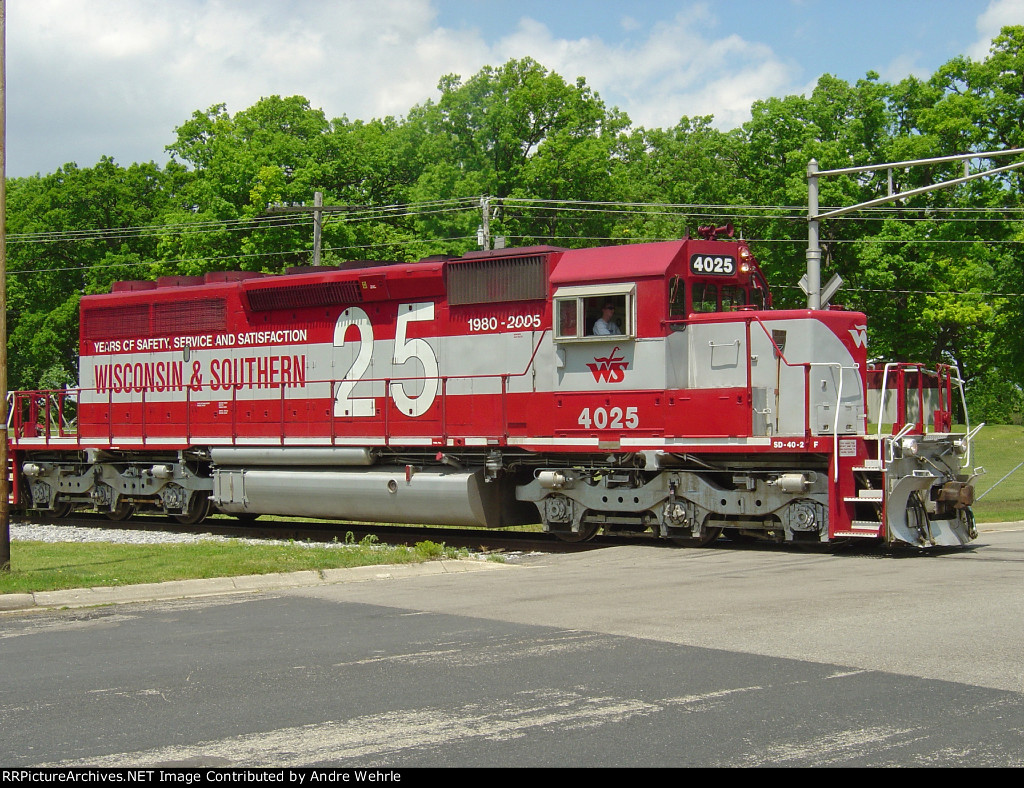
0 531 1024 768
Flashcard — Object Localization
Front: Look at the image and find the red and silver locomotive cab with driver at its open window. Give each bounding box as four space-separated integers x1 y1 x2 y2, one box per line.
551 233 803 447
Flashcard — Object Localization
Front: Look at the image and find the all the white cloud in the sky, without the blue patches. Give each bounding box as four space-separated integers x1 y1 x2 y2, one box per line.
7 0 999 175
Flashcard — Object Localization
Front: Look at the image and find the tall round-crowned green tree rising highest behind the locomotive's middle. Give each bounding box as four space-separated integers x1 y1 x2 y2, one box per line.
403 57 629 248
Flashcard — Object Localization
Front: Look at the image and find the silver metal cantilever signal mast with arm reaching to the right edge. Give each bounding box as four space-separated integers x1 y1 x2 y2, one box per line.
800 147 1024 309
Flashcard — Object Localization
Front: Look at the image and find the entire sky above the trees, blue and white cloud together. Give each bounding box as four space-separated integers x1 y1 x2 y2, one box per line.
7 0 1024 176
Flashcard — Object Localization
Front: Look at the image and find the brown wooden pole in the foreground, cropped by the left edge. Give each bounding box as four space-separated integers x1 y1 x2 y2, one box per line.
0 0 10 572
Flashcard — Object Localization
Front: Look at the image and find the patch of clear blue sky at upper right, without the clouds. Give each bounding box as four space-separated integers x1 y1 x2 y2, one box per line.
437 0 991 81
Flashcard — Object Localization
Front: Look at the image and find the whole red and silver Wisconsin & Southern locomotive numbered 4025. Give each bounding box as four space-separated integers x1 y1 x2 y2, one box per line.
11 228 975 546
